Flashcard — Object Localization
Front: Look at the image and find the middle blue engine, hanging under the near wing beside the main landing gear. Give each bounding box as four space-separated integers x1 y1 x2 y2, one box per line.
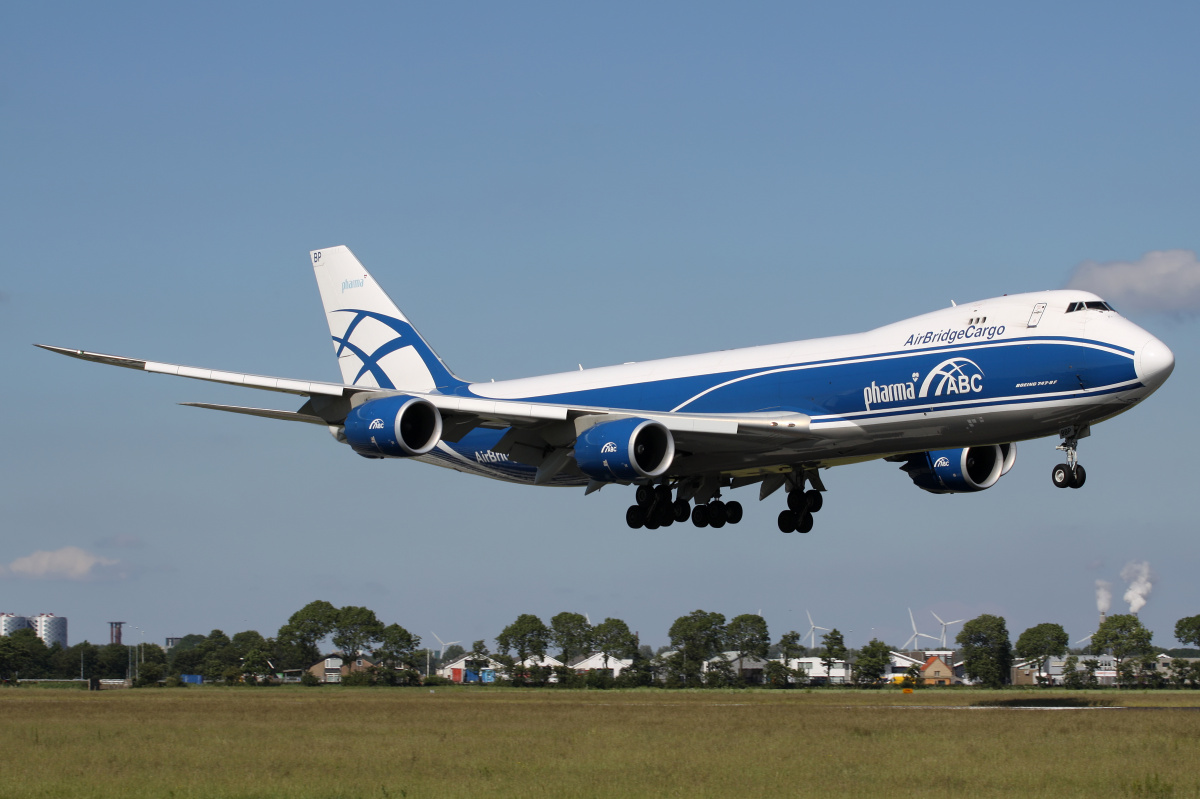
575 419 674 482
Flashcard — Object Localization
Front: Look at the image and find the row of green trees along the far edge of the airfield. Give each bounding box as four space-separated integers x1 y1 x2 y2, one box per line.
7 600 1200 687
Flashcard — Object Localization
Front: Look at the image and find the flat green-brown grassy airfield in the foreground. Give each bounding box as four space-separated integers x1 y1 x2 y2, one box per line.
0 687 1200 799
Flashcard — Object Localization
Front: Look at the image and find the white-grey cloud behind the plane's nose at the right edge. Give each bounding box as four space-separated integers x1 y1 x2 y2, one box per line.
1067 250 1200 316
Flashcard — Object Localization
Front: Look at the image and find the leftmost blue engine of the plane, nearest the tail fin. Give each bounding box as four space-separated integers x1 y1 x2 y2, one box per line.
346 395 442 458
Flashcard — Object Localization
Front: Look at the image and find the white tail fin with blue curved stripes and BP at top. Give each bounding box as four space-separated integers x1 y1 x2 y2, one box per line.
308 246 463 391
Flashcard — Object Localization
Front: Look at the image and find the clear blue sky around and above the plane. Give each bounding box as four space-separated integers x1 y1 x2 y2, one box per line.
0 2 1200 645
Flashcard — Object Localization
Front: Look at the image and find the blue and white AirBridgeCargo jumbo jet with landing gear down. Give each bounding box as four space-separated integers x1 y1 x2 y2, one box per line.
38 247 1175 533
